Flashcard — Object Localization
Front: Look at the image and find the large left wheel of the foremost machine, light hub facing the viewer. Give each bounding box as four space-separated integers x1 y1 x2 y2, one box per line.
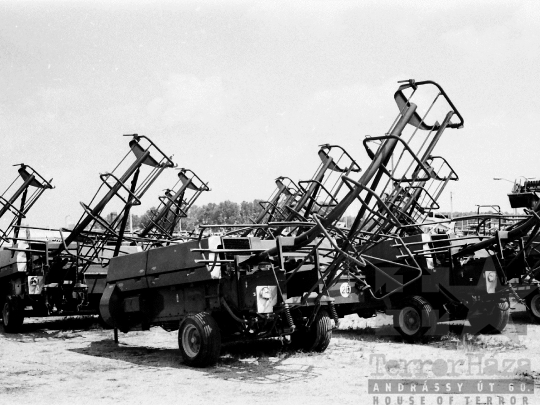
178 312 221 367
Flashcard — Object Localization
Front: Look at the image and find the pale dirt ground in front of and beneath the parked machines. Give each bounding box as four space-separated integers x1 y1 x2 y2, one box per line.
0 304 540 405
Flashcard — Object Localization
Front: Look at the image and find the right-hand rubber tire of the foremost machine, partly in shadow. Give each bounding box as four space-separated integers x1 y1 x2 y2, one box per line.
291 309 332 353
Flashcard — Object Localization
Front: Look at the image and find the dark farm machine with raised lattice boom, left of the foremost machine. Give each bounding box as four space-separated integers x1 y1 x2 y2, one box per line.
0 134 179 332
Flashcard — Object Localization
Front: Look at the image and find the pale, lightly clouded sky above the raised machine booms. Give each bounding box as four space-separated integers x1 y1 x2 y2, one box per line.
0 1 540 226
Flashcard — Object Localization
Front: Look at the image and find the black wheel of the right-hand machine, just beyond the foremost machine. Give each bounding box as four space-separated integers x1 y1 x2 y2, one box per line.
394 295 437 342
